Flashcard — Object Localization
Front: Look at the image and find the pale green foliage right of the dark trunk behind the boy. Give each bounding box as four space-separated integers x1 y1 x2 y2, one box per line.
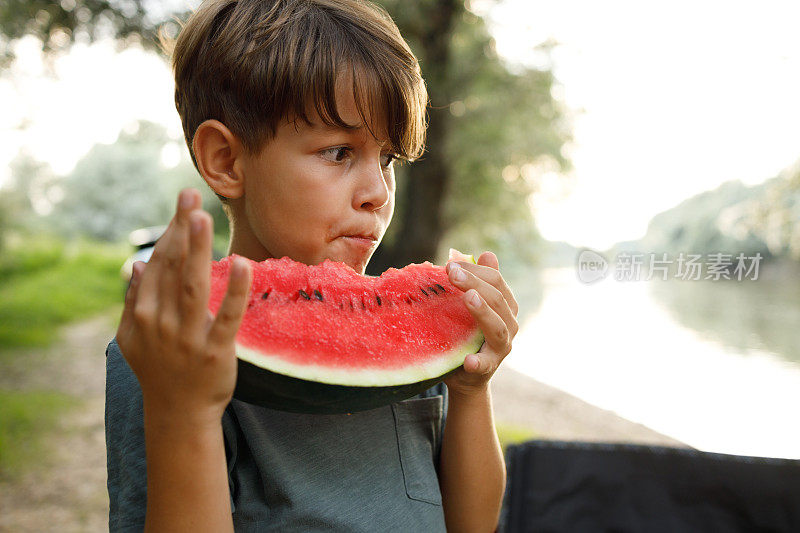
443 23 570 265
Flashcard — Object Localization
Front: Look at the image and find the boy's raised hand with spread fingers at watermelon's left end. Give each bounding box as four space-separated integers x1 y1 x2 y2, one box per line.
117 189 251 423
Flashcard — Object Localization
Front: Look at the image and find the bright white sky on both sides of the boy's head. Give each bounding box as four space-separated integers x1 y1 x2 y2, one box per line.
0 0 800 249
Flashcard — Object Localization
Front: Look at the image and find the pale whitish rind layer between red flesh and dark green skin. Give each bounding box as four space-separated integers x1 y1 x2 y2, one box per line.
236 330 484 387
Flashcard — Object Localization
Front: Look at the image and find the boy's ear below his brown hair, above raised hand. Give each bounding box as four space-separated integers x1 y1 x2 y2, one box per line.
192 120 244 198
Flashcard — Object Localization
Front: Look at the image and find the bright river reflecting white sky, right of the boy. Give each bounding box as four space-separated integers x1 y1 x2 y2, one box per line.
504 268 800 459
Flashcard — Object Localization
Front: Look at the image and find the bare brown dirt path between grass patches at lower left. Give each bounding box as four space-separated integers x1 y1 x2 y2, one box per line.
0 315 115 533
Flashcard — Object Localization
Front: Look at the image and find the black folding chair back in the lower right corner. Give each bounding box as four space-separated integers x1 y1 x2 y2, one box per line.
498 440 800 533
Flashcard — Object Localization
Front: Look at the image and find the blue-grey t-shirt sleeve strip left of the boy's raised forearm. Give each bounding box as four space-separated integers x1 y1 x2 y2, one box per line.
105 339 147 532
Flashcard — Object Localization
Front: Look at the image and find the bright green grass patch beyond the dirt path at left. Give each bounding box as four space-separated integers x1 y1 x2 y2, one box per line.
0 239 130 348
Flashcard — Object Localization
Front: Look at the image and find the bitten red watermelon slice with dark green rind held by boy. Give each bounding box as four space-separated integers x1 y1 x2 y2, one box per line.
209 255 483 413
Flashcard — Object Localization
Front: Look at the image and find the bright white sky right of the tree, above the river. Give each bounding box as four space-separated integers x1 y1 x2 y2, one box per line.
472 0 800 249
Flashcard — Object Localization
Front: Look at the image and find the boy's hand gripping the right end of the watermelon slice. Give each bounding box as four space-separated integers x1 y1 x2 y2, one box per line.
444 252 519 395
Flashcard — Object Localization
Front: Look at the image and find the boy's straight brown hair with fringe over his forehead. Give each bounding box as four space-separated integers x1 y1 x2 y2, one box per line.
162 0 428 175
